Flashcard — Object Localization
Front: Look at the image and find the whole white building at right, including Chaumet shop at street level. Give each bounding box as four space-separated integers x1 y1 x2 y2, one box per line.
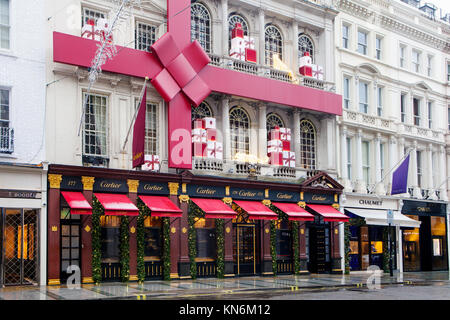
335 0 450 271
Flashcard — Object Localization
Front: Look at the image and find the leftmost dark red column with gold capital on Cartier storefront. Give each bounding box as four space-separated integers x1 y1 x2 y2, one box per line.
47 174 62 285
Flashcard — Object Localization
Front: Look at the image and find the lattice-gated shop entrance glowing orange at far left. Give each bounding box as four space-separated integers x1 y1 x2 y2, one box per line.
0 209 39 286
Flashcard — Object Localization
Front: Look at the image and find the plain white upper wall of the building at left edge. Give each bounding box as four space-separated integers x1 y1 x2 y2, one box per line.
0 0 46 164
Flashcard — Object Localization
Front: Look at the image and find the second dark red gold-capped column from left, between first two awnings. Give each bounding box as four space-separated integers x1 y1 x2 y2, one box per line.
81 177 95 284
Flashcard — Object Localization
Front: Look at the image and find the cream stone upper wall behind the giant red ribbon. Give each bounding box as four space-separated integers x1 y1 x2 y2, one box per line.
46 0 342 178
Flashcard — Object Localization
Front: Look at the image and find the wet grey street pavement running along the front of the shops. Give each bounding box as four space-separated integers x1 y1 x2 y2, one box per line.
0 271 450 300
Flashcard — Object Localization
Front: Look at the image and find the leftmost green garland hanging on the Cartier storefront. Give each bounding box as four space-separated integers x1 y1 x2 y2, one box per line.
92 196 104 285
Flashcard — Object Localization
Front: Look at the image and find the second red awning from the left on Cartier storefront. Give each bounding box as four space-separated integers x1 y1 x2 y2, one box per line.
94 193 139 216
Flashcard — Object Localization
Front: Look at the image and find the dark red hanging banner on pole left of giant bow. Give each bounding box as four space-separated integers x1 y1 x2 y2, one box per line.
133 86 147 168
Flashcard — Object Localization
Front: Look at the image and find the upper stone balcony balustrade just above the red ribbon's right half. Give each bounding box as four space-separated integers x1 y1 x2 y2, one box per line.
209 54 335 92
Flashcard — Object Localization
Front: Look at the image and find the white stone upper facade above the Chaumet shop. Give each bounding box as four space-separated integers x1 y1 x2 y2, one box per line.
335 0 450 200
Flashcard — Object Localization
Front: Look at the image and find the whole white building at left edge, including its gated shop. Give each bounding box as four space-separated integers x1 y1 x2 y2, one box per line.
0 0 47 287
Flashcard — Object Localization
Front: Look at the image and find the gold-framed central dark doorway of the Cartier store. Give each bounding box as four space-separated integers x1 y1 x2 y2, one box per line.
233 223 260 275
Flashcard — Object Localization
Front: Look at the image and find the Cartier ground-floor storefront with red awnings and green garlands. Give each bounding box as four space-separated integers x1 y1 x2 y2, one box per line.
48 165 348 284
